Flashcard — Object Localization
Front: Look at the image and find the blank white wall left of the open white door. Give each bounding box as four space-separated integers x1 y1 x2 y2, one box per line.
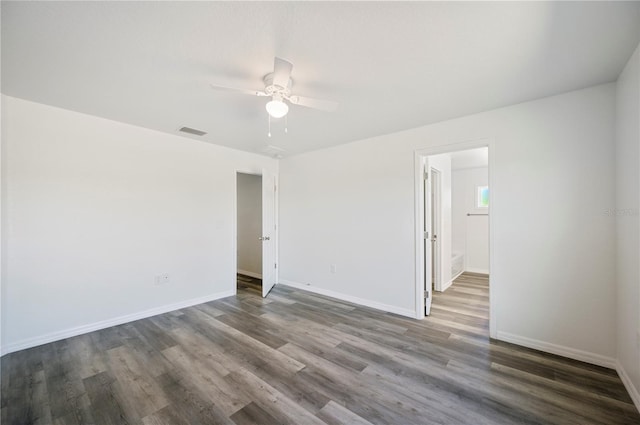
2 97 277 351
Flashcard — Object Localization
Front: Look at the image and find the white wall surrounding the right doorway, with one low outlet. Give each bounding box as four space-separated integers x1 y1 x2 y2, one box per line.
280 84 615 365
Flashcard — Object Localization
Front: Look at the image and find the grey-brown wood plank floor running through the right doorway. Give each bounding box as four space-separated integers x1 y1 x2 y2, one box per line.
1 275 640 425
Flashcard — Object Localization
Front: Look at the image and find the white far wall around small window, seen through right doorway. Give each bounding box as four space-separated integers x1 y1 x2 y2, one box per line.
451 167 491 273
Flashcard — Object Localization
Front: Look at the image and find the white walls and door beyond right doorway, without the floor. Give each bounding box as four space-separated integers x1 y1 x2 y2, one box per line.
421 147 489 316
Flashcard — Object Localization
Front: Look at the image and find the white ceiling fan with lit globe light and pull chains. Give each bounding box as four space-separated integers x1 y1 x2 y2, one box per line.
211 57 338 137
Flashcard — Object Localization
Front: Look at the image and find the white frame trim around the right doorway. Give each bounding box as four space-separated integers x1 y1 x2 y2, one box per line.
414 137 500 338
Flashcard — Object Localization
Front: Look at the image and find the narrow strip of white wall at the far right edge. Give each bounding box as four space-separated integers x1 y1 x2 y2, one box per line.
608 46 640 409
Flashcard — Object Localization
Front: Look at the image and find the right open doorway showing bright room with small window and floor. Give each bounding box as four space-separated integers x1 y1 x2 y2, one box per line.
416 144 490 332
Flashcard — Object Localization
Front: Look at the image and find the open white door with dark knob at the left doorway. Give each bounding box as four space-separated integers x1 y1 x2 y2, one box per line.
261 170 276 297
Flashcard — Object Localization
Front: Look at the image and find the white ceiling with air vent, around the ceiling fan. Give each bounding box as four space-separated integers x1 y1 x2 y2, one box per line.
2 1 640 154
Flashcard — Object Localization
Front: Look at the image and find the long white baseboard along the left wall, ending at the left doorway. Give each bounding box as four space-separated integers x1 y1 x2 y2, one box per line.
0 289 236 355
